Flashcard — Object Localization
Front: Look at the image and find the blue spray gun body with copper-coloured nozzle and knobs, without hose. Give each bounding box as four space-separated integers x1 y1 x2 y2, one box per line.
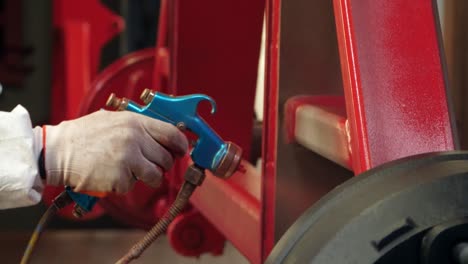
106 89 242 178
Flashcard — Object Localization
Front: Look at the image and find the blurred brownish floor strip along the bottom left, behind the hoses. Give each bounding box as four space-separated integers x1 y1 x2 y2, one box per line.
0 230 248 264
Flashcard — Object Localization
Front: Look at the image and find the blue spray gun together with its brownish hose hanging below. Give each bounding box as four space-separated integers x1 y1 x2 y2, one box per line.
106 89 242 263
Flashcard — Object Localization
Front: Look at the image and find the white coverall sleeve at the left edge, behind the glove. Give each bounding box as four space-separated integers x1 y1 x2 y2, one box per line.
0 105 44 209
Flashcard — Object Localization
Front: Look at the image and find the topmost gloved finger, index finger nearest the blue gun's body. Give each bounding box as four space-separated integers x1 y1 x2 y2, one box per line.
142 117 188 156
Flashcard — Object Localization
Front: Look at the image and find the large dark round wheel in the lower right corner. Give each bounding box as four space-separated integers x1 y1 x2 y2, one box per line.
266 152 468 264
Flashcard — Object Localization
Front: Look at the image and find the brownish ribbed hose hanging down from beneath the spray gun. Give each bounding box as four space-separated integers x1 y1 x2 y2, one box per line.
116 166 204 264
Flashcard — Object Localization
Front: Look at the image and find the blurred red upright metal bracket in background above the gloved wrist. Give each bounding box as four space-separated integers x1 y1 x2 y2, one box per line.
50 0 124 124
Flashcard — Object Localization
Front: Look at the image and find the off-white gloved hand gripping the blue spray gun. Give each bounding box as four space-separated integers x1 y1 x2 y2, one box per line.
38 110 188 193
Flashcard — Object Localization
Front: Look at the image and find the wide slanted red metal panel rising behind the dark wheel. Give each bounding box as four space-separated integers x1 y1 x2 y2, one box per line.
334 0 456 173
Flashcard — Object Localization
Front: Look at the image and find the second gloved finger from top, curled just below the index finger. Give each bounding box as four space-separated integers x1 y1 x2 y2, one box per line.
140 132 174 171
